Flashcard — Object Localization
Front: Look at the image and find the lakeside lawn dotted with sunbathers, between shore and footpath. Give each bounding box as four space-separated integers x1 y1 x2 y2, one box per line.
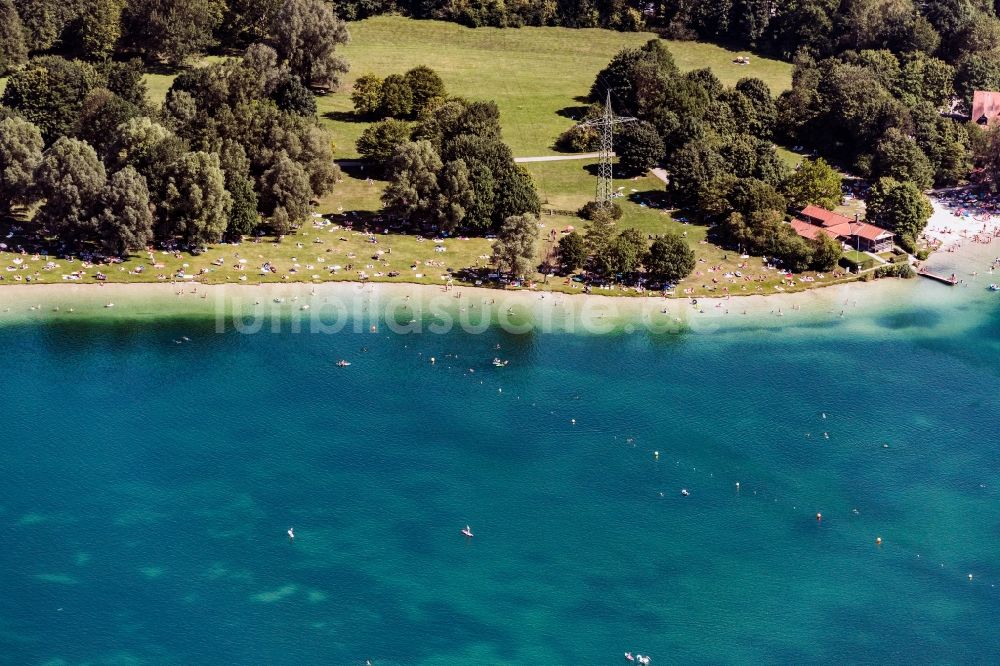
0 161 856 297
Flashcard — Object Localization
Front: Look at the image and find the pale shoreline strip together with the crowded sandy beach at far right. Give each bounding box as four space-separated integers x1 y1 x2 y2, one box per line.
0 199 1000 333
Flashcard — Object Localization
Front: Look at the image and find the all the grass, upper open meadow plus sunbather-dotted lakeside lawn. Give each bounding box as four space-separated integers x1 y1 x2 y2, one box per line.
0 16 832 296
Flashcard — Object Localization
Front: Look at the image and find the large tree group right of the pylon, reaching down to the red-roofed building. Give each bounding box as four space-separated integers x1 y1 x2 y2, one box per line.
559 40 841 270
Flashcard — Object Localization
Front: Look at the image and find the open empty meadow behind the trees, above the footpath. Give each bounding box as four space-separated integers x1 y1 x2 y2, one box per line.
317 16 792 157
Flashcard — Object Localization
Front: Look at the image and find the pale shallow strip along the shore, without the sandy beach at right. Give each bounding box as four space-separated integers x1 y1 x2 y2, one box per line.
0 268 984 334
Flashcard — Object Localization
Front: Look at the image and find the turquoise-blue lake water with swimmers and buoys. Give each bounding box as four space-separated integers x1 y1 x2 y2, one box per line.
0 283 1000 666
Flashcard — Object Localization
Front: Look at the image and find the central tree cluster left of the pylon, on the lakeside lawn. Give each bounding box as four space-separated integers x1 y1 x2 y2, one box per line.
368 98 540 235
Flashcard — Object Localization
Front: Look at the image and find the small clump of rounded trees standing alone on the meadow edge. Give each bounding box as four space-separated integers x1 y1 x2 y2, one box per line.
351 65 448 119
